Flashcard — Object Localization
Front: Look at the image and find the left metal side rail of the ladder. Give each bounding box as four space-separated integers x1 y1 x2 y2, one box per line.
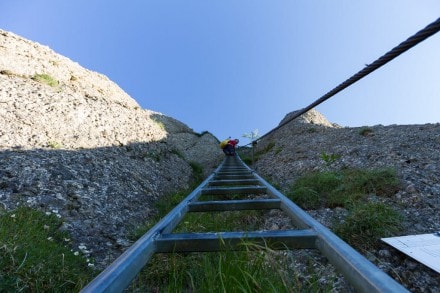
81 162 224 293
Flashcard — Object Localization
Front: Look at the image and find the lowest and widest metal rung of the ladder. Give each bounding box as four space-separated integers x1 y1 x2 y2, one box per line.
156 229 317 253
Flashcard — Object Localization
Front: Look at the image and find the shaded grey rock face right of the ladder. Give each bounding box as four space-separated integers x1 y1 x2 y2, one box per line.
255 113 440 292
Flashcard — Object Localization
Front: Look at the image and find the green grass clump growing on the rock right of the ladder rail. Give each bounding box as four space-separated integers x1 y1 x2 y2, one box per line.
287 169 403 249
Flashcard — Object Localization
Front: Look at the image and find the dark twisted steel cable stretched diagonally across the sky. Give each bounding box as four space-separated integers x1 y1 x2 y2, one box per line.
254 18 440 145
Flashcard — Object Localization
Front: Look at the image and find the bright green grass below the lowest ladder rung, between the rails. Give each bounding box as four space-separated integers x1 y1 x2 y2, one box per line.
131 242 298 292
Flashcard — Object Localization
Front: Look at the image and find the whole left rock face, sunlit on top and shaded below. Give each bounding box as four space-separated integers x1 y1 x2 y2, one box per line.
0 30 222 267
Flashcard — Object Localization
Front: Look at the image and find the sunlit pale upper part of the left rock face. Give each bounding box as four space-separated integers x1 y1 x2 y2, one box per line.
0 31 197 149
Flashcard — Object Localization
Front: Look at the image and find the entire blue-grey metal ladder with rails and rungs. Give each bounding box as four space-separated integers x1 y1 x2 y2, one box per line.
81 156 408 293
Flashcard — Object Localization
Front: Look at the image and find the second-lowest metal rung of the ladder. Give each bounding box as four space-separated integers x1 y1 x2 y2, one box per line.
188 199 281 212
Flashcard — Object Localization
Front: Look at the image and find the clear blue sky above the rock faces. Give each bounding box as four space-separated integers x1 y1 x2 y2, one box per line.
0 0 440 142
